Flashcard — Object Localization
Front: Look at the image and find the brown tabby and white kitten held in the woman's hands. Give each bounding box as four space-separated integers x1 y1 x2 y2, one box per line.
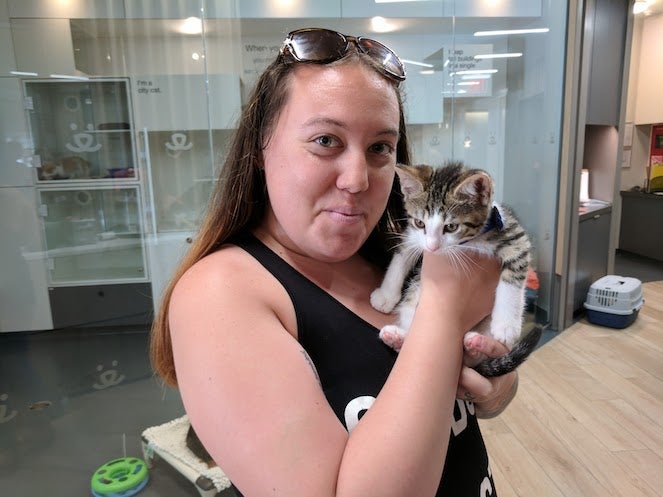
371 162 541 376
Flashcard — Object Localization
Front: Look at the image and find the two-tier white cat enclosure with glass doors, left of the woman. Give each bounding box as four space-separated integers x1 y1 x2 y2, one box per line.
25 79 148 287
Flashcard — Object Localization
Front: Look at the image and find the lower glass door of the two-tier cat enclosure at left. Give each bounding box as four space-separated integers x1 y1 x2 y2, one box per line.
40 187 146 285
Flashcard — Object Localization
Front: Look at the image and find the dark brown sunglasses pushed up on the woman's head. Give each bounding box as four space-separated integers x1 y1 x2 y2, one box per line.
280 28 405 81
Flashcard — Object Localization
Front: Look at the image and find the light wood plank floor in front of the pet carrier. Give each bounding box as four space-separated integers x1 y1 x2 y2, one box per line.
481 281 663 497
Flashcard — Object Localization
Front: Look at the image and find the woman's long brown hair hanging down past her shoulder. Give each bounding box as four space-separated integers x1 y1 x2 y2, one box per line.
150 52 410 386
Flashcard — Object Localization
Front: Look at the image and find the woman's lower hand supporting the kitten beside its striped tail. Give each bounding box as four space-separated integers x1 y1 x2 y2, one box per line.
457 335 518 418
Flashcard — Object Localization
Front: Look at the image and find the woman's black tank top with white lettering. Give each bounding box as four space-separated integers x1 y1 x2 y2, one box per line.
231 234 497 497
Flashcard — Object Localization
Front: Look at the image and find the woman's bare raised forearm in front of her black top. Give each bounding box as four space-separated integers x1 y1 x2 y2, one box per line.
337 294 462 496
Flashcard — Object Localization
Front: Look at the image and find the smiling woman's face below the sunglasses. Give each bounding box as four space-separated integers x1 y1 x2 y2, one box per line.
262 63 400 262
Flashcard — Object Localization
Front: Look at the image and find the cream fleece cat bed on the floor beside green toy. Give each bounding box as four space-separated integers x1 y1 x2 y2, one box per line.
141 415 231 497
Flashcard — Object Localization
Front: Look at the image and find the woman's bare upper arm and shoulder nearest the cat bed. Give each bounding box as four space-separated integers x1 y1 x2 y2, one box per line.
170 249 347 495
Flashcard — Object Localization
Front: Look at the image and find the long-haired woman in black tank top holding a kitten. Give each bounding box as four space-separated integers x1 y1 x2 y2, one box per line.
152 28 516 497
